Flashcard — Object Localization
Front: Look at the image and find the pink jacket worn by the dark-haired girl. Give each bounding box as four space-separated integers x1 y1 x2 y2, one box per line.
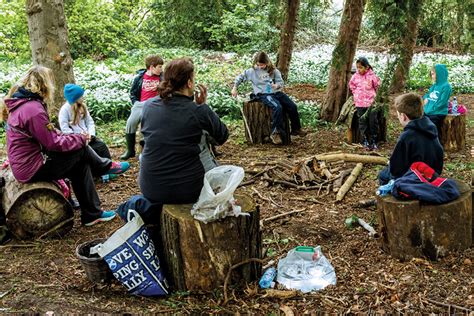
349 69 380 108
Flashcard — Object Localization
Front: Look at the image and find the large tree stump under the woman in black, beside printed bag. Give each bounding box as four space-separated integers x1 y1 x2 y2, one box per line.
161 195 261 291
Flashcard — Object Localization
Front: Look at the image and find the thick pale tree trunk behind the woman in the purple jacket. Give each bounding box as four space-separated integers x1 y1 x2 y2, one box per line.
26 0 74 116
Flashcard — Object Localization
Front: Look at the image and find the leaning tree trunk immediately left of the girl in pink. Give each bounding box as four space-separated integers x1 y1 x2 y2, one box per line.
321 0 365 122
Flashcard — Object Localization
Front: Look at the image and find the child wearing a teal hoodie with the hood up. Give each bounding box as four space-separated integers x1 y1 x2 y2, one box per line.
423 64 452 137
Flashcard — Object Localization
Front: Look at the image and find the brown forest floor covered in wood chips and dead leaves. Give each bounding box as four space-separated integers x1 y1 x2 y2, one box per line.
0 85 474 315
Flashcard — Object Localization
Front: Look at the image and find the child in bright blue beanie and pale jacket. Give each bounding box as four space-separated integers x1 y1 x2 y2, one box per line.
58 83 111 159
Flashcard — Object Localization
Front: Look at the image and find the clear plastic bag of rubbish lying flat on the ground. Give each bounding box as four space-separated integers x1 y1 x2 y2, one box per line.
277 246 336 293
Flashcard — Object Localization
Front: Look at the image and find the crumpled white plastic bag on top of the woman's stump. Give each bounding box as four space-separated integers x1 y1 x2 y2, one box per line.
191 165 249 223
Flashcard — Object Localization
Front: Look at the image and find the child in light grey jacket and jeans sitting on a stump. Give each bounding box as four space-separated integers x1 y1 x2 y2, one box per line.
231 52 305 145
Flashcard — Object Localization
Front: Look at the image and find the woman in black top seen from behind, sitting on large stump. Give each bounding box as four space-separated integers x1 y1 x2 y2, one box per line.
133 58 229 218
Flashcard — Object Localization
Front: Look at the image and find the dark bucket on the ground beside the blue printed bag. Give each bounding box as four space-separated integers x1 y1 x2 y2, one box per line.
76 239 113 283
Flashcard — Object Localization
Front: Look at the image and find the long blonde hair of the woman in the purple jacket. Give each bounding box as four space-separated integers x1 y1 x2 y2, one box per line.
12 65 54 104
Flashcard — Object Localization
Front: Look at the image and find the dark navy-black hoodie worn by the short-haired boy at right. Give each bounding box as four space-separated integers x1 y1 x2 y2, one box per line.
390 116 444 178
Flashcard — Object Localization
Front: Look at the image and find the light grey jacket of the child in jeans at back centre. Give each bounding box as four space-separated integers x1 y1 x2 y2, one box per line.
234 68 284 94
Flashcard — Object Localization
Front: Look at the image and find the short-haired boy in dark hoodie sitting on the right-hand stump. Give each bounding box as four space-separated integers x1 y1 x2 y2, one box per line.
379 93 444 185
